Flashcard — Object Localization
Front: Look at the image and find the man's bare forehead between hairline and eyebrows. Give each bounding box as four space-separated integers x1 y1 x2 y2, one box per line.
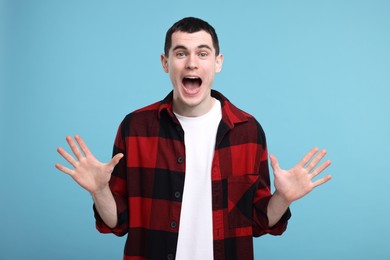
171 31 215 51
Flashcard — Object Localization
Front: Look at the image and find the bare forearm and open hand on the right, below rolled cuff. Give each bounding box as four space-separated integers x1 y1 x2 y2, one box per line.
267 148 332 227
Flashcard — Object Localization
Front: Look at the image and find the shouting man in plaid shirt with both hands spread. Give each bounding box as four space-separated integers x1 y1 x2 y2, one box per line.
56 17 331 260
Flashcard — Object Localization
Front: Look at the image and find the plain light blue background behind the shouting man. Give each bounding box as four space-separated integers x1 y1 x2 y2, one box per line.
0 0 390 260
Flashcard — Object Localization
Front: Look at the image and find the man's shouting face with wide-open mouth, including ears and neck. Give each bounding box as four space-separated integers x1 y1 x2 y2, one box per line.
161 31 223 116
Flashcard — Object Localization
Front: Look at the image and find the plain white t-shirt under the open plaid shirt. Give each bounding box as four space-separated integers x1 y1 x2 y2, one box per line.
176 99 222 260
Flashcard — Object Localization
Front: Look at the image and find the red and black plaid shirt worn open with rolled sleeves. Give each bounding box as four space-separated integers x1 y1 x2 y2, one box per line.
95 90 290 260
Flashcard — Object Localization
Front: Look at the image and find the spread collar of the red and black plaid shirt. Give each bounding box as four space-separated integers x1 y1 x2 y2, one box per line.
158 89 249 128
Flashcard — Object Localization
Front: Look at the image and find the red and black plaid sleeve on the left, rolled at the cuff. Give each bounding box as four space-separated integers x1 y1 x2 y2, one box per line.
93 122 129 236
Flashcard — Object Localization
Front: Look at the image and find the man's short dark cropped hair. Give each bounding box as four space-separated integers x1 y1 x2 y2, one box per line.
164 17 219 56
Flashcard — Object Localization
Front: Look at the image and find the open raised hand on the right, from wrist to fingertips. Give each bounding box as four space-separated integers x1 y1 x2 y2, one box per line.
270 148 332 203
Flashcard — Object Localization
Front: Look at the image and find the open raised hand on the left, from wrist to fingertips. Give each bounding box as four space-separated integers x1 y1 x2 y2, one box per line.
55 136 123 194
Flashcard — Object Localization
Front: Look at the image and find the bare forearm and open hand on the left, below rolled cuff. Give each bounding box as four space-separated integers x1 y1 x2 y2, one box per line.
55 136 123 228
